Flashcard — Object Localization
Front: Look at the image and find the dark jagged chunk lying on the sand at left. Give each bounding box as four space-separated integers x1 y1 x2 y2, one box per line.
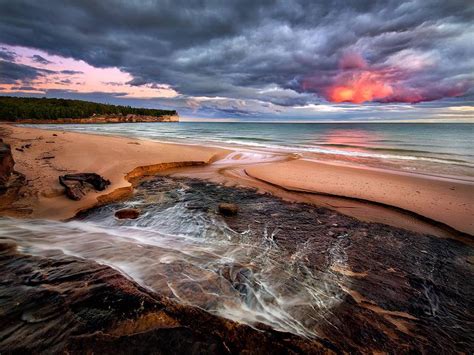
59 173 110 201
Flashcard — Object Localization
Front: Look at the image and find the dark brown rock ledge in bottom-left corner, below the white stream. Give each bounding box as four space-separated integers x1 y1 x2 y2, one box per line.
0 242 333 354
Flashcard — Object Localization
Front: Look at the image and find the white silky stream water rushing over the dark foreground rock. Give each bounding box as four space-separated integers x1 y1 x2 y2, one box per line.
0 179 354 337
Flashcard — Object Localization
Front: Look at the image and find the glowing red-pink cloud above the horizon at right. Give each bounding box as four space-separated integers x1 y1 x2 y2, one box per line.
303 53 468 104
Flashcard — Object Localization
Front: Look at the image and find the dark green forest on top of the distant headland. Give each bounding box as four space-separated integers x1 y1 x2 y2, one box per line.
0 96 177 121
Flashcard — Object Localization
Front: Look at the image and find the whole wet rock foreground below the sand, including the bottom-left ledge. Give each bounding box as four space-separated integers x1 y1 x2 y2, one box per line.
0 178 474 353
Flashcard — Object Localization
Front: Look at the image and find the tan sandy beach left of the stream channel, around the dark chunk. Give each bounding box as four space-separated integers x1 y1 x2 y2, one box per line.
0 125 225 220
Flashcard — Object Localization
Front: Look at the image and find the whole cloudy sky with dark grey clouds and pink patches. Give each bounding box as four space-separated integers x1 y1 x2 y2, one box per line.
0 0 474 122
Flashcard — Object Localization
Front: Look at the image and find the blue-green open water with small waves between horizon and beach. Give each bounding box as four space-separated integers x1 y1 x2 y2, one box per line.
25 122 474 177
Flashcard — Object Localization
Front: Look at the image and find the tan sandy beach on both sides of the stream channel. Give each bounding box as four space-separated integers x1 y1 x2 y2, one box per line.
0 125 474 235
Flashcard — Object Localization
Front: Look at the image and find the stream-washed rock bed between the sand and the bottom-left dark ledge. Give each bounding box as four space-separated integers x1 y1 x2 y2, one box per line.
0 177 474 353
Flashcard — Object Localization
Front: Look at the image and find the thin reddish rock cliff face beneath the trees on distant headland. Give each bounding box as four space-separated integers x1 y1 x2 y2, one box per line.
13 115 179 124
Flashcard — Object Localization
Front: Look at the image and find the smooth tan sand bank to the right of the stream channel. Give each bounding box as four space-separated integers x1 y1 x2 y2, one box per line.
245 159 474 234
